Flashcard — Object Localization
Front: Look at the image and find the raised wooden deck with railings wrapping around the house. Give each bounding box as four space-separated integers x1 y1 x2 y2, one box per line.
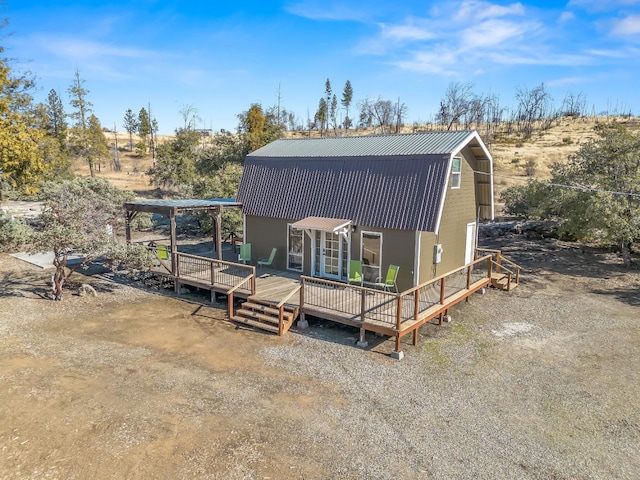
148 248 519 352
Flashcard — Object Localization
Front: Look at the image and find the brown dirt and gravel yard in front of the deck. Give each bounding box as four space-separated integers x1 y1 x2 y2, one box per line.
0 240 640 479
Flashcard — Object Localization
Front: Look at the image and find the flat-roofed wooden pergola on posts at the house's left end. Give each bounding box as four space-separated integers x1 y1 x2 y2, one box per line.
124 198 242 273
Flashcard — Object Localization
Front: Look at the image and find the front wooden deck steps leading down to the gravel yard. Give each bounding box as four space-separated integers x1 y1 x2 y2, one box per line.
232 297 299 335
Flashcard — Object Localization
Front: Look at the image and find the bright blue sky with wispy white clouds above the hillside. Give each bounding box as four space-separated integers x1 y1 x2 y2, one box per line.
2 0 640 133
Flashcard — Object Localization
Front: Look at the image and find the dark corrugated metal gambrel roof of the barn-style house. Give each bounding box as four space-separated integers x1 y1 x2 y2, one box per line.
237 131 493 232
